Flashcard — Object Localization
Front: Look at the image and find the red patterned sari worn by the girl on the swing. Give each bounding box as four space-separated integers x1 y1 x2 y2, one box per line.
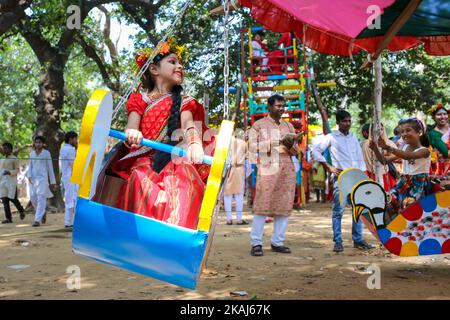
113 93 214 229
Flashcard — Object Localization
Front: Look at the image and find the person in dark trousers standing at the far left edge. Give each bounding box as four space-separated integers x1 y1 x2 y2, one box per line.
0 142 25 223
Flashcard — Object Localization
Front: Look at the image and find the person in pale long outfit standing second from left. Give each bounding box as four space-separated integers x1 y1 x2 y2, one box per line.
27 136 56 227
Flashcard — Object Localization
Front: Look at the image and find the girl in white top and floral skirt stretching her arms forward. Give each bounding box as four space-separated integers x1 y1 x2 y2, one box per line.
374 118 431 218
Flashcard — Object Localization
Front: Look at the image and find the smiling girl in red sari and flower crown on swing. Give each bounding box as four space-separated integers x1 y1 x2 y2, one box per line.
113 40 213 229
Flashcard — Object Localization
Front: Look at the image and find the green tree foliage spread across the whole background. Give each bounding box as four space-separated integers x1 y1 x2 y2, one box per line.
0 0 450 151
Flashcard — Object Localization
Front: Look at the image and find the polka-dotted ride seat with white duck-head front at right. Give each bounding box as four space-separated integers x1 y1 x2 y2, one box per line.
338 168 450 256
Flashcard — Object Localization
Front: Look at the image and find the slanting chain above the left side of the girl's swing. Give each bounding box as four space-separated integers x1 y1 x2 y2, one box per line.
112 0 193 121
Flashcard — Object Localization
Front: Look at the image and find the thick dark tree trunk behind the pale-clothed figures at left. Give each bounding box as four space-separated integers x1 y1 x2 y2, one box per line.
35 57 64 210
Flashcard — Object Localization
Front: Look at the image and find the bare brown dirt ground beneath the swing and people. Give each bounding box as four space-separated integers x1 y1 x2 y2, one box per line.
0 203 450 300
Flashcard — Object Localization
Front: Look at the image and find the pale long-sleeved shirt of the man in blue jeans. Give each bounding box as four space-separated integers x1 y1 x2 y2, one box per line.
312 131 366 171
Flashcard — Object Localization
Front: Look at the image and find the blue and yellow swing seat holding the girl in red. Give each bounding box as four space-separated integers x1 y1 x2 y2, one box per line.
71 89 234 289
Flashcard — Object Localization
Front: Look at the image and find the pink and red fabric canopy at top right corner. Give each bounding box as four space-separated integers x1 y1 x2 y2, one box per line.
241 0 450 56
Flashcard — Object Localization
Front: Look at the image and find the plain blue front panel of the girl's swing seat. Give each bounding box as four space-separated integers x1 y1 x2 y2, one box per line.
72 198 208 289
